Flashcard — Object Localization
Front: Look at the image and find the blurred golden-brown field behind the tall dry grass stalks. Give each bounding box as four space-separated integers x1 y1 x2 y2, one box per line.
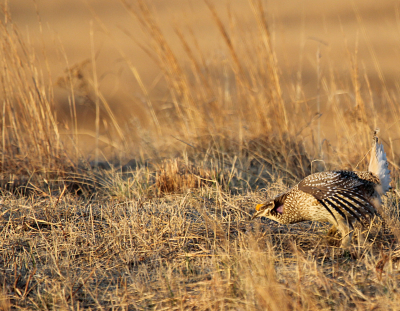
9 0 400 159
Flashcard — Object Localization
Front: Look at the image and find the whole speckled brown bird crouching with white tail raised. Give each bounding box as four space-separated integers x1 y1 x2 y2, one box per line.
252 129 391 249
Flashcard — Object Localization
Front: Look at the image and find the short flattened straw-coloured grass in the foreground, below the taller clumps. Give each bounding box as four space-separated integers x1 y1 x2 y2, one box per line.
0 179 400 310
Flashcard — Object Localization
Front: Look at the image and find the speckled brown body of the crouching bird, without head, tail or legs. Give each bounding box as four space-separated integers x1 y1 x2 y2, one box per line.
281 171 379 227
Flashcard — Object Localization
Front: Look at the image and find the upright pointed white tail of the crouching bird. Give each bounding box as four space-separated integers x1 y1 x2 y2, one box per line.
368 129 390 194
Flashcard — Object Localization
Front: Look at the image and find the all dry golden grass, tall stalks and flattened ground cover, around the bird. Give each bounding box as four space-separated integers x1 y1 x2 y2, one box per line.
0 0 400 310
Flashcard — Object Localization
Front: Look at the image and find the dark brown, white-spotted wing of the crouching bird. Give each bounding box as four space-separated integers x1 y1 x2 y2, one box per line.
298 171 377 221
